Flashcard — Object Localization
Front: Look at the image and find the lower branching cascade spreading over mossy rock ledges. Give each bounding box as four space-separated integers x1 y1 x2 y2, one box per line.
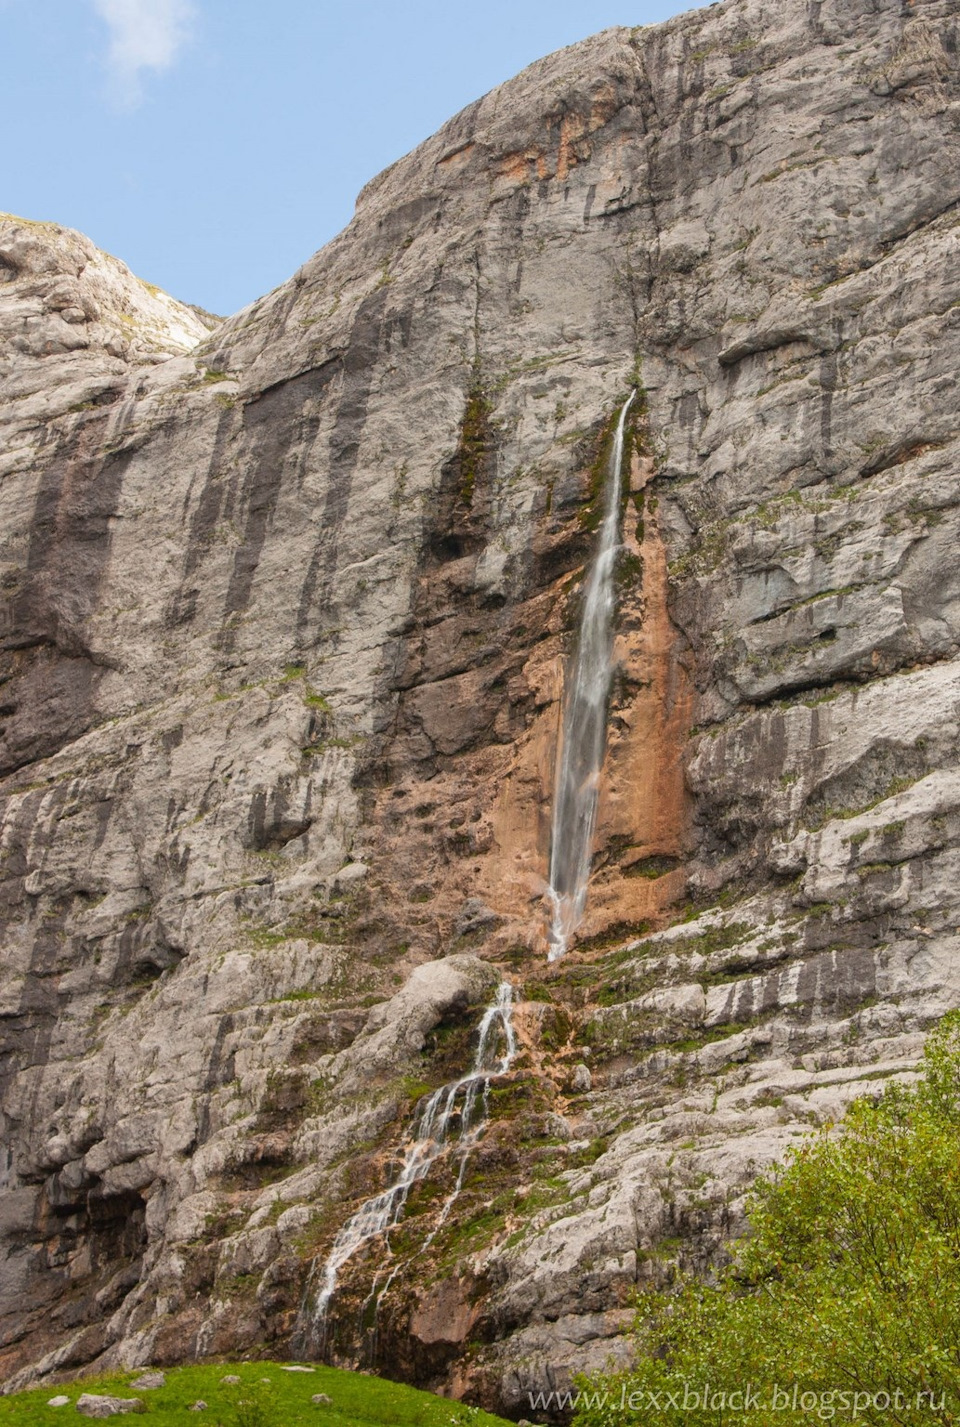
308 982 516 1344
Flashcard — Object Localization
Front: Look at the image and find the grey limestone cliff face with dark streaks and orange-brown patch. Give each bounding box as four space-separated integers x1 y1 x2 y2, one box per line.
0 0 960 1414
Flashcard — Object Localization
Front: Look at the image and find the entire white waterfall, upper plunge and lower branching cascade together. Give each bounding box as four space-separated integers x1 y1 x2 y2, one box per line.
305 391 636 1349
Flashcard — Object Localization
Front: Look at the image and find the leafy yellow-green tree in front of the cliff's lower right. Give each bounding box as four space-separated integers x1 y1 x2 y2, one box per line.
576 1012 960 1427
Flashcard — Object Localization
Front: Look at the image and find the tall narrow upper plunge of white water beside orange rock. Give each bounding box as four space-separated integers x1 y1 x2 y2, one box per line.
548 391 636 962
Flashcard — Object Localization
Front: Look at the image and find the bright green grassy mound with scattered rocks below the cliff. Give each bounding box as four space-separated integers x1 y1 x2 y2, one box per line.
0 1363 509 1427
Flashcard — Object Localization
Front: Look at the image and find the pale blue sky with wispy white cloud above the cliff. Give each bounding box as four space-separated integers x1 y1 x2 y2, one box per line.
0 0 689 314
